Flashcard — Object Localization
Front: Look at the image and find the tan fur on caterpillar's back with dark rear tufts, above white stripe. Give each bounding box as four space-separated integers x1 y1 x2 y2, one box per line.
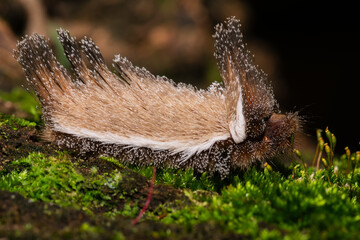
16 31 228 147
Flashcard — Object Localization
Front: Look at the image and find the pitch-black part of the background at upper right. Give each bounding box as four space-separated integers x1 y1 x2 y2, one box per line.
249 1 360 151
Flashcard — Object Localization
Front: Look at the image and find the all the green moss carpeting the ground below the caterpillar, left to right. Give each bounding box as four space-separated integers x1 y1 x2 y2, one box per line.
0 124 360 239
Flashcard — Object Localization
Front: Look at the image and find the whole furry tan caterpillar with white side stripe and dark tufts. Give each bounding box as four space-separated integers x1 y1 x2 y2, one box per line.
14 17 299 178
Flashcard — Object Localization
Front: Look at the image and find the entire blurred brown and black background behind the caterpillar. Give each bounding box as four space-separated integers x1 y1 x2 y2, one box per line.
0 0 360 153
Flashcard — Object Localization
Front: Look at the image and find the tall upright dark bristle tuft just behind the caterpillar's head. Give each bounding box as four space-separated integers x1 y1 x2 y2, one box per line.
213 17 277 138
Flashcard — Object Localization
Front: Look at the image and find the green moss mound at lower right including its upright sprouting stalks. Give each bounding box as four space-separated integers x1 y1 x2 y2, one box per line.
157 129 360 239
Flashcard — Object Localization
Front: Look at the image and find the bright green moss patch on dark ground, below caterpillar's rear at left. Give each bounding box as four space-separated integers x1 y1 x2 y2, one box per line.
0 153 121 213
